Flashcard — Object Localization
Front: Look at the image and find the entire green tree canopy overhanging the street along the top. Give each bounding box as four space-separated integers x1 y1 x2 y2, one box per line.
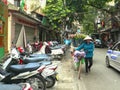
44 0 119 32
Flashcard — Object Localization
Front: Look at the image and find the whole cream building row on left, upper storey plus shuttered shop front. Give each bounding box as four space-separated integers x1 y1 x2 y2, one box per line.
8 0 58 52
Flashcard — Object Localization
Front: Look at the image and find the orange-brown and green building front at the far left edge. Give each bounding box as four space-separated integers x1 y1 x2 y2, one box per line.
0 1 8 59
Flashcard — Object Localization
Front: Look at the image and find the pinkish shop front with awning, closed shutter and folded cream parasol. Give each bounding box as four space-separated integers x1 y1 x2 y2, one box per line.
9 10 40 47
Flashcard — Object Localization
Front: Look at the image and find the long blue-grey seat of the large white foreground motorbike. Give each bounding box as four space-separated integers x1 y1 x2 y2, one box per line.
10 63 41 73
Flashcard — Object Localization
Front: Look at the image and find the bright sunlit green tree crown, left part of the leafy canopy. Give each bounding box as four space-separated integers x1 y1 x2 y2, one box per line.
44 0 70 30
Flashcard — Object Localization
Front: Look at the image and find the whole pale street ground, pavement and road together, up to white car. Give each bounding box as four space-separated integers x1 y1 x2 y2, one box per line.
47 48 120 90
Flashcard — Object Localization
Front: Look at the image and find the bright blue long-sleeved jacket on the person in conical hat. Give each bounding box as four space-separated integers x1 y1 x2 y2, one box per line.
76 42 94 58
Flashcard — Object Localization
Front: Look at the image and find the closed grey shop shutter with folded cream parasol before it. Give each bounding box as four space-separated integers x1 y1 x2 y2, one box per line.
14 23 35 46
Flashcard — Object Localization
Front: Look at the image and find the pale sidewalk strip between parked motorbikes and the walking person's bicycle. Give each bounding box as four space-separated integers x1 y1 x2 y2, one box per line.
47 51 86 90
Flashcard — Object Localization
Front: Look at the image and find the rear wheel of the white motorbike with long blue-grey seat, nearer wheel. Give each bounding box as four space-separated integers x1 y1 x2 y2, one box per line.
27 76 46 90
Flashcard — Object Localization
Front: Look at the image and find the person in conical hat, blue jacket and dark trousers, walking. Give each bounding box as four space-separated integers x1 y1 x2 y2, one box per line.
76 36 94 73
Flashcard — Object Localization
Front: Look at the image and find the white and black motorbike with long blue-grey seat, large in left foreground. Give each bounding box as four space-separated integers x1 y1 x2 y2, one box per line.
0 51 46 90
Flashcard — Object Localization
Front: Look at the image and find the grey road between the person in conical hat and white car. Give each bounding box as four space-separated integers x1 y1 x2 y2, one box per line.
82 48 120 90
